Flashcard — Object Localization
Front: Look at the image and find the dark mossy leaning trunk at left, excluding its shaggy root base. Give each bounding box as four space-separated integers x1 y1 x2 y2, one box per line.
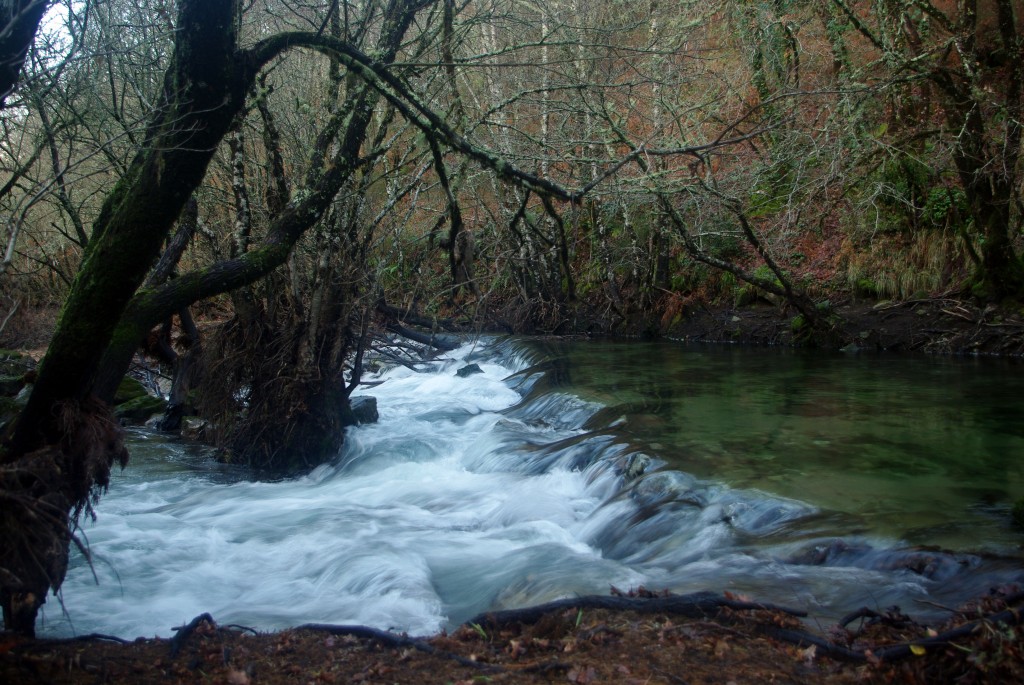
8 0 246 455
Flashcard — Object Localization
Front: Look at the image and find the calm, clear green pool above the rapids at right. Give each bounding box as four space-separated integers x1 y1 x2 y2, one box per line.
524 341 1024 554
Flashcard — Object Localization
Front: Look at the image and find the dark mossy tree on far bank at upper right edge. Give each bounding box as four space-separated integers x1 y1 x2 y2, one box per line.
833 0 1024 299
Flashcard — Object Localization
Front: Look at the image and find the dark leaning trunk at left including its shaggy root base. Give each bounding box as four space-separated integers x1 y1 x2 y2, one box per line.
0 0 246 634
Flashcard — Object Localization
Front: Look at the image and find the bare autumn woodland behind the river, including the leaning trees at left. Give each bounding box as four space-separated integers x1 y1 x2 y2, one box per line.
0 0 1024 655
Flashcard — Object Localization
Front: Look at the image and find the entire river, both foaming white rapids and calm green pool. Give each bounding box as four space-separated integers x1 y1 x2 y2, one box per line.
39 339 1024 637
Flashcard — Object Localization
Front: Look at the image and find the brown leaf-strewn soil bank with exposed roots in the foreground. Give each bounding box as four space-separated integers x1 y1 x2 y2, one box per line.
0 594 1024 685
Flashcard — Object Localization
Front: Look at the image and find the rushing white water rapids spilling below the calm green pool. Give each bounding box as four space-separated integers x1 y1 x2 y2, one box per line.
40 335 1021 637
